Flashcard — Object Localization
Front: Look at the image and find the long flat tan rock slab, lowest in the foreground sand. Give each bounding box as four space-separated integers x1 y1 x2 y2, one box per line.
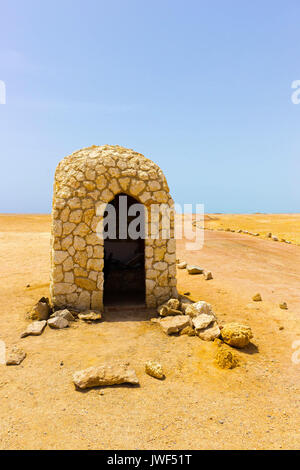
73 363 139 390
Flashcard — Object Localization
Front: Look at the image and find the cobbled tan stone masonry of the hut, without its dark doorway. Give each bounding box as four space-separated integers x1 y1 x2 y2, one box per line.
51 145 176 310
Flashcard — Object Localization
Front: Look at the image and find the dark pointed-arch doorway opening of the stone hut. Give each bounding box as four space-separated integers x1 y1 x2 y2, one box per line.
104 193 146 306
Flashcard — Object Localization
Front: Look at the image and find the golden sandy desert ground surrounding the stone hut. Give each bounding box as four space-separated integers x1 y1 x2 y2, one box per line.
0 214 300 449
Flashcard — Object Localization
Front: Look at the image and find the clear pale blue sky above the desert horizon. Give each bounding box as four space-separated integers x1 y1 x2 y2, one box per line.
0 0 300 213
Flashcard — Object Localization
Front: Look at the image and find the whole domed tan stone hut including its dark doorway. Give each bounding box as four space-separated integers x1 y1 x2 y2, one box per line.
50 145 177 310
